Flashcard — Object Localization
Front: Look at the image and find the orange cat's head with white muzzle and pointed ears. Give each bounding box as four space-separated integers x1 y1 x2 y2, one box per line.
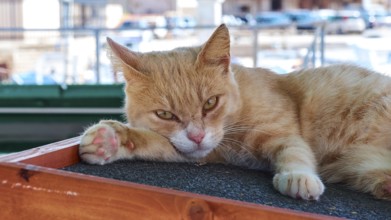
108 25 240 158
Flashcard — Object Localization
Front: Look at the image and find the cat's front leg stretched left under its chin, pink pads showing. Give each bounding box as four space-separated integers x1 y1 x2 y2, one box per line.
79 120 185 165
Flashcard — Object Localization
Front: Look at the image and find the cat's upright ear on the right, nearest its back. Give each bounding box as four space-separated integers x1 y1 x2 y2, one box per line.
196 24 230 71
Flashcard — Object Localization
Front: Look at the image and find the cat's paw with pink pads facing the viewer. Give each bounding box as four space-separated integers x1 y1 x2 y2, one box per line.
79 123 133 165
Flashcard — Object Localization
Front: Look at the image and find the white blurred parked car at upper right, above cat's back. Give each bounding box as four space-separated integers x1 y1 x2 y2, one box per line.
326 10 366 34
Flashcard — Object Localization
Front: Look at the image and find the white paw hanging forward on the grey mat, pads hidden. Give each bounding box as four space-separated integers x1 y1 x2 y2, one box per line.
273 172 325 200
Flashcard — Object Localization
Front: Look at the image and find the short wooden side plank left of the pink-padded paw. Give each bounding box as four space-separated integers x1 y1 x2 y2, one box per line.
0 137 80 168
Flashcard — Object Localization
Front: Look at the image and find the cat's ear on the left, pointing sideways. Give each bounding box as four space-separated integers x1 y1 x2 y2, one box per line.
107 37 147 83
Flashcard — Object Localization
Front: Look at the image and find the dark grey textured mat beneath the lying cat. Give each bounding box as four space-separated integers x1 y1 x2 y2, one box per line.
64 161 391 219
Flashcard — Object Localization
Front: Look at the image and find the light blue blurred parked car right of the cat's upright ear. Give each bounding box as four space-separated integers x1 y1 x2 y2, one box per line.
255 12 292 29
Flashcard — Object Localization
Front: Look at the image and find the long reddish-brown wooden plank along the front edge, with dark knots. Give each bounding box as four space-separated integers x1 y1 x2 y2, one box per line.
0 163 333 220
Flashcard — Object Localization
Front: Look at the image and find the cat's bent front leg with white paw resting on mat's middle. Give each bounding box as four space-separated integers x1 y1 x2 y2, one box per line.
265 136 325 200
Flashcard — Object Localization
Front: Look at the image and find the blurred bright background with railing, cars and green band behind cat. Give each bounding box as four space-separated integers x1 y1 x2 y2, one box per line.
0 0 391 152
